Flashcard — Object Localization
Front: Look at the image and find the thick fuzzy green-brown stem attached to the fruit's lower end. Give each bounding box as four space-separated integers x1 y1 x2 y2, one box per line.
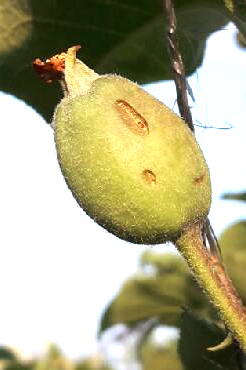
175 223 246 352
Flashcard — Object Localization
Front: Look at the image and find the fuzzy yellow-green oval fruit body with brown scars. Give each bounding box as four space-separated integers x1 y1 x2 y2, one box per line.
54 75 211 244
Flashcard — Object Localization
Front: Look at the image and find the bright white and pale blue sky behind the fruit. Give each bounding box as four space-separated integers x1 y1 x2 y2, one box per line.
0 22 246 357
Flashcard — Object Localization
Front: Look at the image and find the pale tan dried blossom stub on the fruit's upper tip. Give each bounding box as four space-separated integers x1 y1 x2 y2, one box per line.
65 45 99 97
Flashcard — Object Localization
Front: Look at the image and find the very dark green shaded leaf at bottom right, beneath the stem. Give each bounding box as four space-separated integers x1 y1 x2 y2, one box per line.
178 311 238 370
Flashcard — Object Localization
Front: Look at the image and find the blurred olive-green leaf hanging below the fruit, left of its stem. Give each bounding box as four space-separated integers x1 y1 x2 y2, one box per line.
99 252 214 334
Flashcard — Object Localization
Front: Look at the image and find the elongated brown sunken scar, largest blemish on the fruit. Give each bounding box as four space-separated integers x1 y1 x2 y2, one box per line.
115 100 149 136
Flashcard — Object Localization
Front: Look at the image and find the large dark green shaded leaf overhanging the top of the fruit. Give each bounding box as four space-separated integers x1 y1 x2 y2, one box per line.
0 0 231 121
